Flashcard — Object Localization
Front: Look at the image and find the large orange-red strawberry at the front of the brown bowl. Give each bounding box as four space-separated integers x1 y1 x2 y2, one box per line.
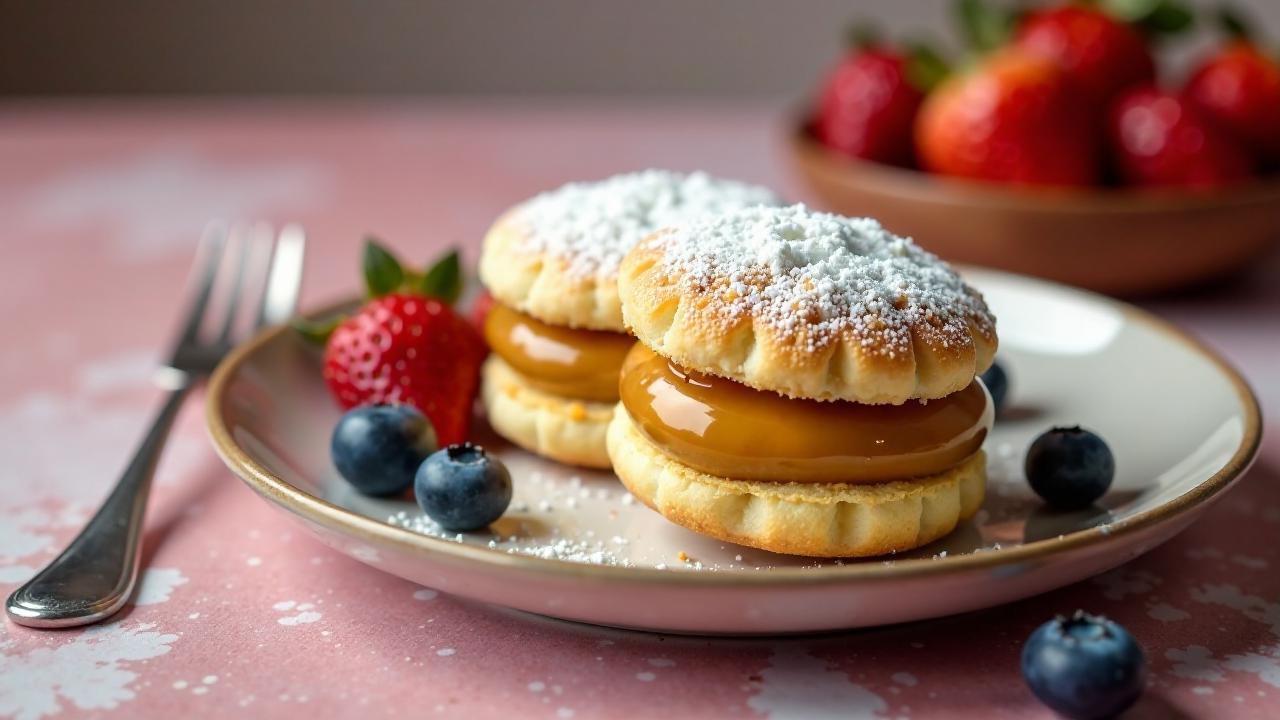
915 50 1100 184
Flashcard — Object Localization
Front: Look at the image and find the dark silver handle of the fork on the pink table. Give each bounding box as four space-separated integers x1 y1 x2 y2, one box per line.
5 375 191 628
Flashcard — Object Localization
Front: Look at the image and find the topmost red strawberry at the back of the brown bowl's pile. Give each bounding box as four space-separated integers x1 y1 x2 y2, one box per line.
1014 5 1156 108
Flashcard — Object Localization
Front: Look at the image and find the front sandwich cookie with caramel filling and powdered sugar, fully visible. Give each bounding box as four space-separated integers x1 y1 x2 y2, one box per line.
608 205 997 556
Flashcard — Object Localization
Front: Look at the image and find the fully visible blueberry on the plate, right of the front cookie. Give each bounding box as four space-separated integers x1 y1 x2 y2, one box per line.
1023 427 1116 510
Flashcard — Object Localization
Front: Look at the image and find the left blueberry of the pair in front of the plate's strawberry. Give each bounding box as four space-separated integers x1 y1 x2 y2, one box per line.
329 405 435 496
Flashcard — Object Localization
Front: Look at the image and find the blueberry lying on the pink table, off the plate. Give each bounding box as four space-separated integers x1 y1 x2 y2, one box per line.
1023 610 1147 720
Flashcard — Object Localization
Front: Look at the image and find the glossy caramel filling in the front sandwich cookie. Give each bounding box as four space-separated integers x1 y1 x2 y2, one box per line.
621 345 995 483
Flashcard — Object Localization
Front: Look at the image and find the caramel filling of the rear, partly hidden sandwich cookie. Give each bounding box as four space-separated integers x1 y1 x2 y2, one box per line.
484 302 636 402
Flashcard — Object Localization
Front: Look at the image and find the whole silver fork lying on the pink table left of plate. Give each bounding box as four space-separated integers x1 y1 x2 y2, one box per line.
5 225 306 628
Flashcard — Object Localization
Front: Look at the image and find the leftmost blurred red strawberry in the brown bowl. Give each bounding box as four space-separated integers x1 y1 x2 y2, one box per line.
813 46 932 165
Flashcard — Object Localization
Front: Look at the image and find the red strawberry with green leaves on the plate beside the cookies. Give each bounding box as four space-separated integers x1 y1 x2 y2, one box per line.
300 241 486 446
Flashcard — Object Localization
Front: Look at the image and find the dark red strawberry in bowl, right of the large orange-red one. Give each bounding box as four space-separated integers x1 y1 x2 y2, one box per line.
1107 87 1252 188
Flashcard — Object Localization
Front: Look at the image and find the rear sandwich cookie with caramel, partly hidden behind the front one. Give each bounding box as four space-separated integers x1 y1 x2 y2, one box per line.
480 170 777 468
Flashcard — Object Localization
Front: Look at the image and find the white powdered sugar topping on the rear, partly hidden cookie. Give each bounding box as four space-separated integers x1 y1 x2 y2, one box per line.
512 170 778 277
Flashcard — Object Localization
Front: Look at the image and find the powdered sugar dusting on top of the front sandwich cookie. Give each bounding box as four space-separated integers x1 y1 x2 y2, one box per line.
654 205 995 356
